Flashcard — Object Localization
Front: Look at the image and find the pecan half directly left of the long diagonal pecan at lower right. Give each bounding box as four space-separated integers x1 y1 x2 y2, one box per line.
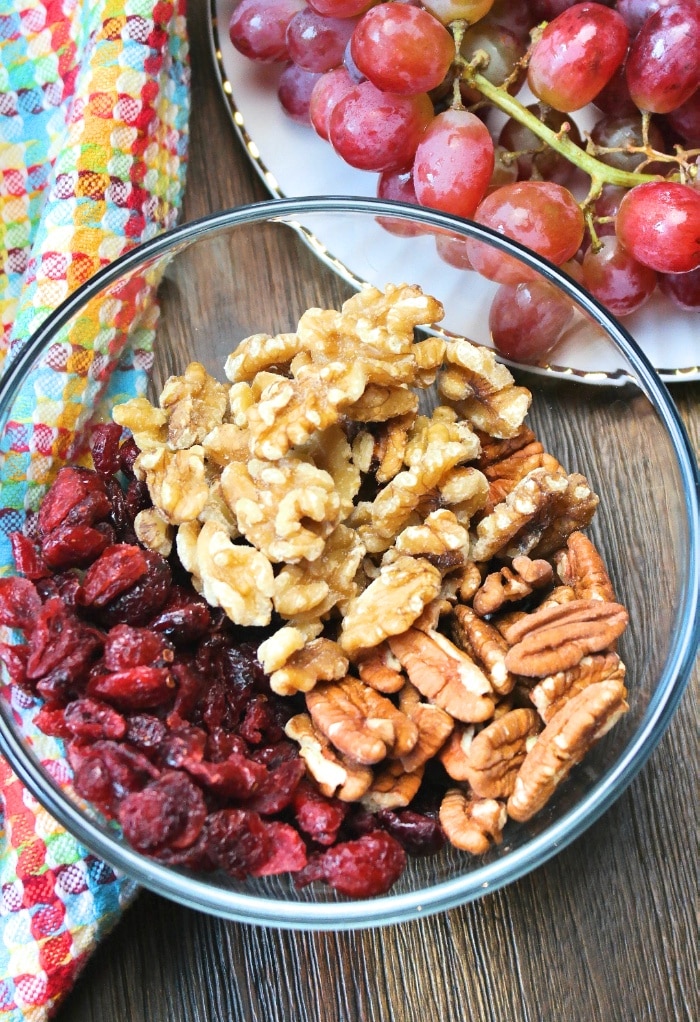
466 709 542 798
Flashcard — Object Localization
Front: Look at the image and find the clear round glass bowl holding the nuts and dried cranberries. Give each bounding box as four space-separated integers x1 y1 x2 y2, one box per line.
0 197 700 929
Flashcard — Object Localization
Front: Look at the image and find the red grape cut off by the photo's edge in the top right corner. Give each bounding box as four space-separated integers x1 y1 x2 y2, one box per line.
625 0 700 113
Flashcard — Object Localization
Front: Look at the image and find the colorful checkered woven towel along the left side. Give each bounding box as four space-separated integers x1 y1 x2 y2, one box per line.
0 0 189 1022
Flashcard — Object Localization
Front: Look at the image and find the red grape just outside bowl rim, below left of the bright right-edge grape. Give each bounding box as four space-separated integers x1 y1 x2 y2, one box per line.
582 237 656 316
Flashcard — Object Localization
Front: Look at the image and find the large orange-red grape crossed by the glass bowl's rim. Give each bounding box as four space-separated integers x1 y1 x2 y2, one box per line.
468 181 584 284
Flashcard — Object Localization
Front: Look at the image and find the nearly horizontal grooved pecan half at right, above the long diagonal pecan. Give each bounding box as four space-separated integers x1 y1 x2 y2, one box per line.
506 600 628 678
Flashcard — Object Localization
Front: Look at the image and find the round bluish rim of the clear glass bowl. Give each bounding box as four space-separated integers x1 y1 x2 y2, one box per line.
0 195 700 930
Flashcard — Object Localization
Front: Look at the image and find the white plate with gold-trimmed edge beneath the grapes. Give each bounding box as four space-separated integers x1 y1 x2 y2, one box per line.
209 0 700 382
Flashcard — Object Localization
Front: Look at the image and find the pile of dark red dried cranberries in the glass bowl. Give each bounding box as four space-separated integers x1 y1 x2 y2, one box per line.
0 423 445 897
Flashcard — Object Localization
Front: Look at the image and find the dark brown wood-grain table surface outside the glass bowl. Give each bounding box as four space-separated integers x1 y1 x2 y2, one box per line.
58 7 700 1022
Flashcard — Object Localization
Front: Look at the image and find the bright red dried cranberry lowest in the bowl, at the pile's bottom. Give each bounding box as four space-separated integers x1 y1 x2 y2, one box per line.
295 831 406 897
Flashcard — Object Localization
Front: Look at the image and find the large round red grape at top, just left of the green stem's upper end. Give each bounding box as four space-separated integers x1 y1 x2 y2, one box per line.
351 3 455 95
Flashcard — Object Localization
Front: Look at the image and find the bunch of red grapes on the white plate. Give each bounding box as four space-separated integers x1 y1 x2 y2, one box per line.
230 0 700 362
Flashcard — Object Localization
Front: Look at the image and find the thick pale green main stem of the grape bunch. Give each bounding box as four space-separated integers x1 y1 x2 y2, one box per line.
462 70 663 197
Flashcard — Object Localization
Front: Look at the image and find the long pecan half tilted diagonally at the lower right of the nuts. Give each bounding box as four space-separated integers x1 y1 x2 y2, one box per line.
508 680 629 823
